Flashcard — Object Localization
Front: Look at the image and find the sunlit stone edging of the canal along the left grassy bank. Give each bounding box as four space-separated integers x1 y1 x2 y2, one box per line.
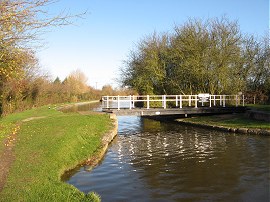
84 114 118 170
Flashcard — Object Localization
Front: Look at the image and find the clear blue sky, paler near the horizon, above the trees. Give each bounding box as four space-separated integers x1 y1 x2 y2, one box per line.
38 0 269 89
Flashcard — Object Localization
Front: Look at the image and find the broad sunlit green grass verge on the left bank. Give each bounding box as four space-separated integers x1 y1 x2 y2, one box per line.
0 106 112 201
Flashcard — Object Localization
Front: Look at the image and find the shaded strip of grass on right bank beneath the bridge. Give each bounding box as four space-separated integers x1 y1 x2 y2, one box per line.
184 114 270 130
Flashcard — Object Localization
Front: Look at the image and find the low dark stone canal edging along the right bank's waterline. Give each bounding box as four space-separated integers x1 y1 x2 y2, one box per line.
175 119 270 136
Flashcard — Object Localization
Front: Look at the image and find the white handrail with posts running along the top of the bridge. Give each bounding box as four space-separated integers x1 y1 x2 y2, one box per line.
102 94 245 110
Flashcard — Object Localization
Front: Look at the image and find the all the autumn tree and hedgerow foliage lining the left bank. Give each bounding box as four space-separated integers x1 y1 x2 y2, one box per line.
0 0 131 116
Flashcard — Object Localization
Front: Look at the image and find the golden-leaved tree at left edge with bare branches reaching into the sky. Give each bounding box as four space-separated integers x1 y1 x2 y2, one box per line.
0 0 86 115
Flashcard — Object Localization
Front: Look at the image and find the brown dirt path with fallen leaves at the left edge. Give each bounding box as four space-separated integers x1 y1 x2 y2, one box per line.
0 125 20 192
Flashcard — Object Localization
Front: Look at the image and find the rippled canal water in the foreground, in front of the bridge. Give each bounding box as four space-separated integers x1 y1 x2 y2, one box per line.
62 104 270 201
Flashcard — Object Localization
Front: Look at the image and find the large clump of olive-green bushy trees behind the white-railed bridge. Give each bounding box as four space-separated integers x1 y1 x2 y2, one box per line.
121 17 270 103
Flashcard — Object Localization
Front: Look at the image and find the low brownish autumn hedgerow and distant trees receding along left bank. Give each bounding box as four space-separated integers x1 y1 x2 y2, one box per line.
1 67 131 115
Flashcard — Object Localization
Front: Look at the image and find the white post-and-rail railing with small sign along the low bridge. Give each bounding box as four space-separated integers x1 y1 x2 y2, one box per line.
102 94 245 110
